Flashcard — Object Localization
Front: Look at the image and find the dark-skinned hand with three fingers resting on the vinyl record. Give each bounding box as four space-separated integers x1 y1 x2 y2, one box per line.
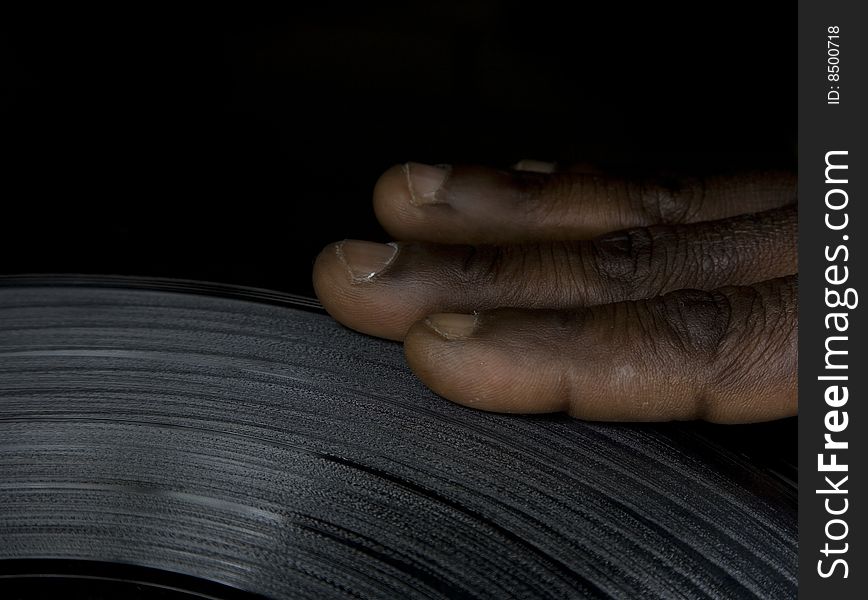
313 161 798 423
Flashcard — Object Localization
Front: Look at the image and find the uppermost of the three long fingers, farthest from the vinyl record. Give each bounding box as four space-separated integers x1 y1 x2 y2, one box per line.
374 163 796 244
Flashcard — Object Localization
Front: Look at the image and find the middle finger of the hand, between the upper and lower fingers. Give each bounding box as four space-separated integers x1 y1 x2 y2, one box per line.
313 206 797 339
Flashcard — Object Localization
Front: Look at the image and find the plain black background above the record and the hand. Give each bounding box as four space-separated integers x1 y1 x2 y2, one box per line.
0 1 797 295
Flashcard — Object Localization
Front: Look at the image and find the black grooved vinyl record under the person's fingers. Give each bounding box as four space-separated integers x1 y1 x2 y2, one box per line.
0 278 797 599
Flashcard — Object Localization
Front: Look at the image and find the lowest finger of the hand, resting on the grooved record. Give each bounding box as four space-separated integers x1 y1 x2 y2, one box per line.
404 277 797 423
